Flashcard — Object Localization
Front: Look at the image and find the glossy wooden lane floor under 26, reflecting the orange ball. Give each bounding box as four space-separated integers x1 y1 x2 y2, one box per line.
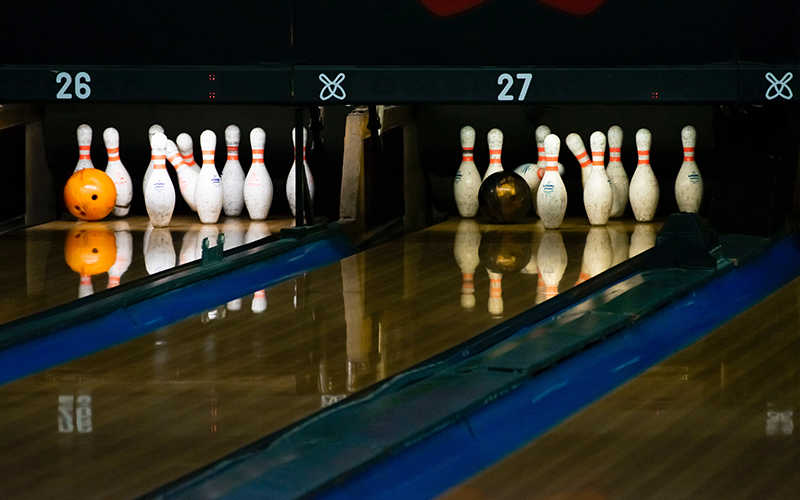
0 216 293 325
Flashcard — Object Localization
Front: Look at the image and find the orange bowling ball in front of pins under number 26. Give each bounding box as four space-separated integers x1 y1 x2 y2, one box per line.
64 168 117 220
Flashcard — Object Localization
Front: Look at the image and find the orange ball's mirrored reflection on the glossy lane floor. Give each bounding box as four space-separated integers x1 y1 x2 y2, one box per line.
64 223 117 276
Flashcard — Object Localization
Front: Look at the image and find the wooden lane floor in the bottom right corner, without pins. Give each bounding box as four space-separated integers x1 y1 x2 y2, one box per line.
439 279 800 500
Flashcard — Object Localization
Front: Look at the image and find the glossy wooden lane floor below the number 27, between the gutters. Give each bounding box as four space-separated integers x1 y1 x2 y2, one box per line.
0 219 657 498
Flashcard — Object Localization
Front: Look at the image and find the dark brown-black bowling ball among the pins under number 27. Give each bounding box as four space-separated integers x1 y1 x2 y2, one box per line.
478 171 531 224
